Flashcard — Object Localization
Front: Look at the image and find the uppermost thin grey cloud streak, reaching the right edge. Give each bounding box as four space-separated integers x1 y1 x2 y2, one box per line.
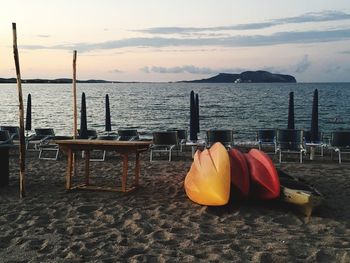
134 10 350 34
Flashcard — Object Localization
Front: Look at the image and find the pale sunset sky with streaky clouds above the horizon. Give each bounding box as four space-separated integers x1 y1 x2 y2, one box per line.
0 0 350 82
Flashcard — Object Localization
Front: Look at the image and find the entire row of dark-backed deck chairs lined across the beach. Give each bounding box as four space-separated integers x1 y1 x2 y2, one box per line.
0 126 350 163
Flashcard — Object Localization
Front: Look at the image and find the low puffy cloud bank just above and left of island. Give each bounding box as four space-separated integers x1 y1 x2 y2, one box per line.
140 65 244 75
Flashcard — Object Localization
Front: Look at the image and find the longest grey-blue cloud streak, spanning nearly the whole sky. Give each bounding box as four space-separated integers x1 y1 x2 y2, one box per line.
21 29 350 52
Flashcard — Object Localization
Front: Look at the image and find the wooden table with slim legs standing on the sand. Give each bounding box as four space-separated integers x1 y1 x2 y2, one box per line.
55 139 152 192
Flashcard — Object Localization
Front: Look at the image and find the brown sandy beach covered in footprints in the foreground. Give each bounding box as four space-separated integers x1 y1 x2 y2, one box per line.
0 147 350 263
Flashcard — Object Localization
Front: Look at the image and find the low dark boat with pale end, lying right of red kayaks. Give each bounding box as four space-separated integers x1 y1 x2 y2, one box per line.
278 170 323 217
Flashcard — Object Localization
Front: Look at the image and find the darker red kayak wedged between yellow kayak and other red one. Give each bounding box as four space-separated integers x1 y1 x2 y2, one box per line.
229 149 250 196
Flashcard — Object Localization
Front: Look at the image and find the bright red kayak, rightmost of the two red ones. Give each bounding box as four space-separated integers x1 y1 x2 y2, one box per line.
244 149 280 199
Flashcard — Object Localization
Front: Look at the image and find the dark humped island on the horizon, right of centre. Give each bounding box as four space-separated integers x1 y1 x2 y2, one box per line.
180 70 297 83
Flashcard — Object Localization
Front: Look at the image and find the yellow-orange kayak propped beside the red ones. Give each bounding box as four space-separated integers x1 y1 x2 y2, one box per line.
184 143 231 206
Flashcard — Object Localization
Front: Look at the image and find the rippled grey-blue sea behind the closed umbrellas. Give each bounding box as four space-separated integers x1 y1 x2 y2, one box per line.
0 83 350 142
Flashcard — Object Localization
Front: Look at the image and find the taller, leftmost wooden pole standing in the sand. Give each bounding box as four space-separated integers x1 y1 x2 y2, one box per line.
12 23 25 198
